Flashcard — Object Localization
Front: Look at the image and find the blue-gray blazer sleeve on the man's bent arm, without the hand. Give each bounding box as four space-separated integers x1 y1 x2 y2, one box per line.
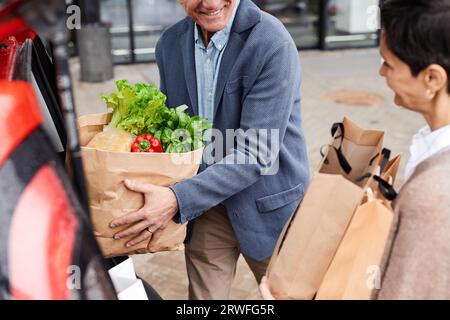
171 41 300 223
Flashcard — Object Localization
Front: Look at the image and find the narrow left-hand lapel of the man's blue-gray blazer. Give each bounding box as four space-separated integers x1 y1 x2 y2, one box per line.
179 19 198 115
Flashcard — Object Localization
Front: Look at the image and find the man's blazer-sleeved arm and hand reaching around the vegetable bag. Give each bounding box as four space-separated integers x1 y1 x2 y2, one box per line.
110 42 300 248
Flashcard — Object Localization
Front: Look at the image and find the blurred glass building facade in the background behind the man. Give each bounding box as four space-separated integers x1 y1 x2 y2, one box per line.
100 0 380 63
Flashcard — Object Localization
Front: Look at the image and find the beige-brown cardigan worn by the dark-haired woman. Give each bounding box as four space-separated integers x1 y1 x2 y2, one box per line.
377 149 450 299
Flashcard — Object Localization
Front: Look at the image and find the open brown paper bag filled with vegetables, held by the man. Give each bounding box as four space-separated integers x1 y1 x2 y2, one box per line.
78 114 203 257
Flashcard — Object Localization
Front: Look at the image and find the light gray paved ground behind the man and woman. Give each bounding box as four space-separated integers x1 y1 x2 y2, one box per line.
71 49 423 299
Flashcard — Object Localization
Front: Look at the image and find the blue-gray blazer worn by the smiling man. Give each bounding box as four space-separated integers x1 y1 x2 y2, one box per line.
156 0 310 260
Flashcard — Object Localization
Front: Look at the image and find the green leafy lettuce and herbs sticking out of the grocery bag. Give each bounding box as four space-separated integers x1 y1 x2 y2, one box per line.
101 80 212 152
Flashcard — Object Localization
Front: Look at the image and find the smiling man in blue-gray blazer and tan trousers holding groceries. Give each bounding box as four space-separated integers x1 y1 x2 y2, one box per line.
112 0 310 299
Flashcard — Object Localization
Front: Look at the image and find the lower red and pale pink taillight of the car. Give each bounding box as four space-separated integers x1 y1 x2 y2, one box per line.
9 166 81 300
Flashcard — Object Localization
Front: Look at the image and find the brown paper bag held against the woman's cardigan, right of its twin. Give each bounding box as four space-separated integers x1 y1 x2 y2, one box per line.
316 155 401 300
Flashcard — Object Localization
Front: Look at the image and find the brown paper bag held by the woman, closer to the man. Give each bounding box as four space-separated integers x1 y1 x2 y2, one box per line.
267 118 384 299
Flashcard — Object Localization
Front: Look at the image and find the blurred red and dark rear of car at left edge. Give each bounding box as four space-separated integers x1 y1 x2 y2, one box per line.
0 1 160 300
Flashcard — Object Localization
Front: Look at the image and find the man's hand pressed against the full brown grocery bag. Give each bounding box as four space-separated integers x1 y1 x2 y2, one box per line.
110 180 178 248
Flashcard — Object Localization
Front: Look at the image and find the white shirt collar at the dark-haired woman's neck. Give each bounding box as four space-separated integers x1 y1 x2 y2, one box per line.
405 125 450 178
